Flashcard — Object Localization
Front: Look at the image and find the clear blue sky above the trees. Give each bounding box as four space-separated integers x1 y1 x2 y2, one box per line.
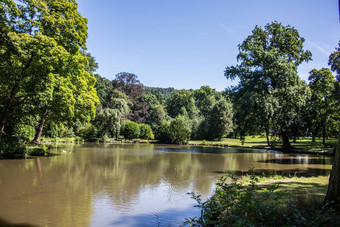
77 0 340 90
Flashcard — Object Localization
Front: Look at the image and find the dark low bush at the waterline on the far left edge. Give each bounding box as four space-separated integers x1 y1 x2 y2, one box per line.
0 135 28 158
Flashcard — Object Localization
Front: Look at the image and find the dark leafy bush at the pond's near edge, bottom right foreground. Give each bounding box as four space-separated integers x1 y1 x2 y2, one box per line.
186 171 306 226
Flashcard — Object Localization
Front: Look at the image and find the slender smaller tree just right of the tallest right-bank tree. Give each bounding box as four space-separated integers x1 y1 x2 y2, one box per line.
308 68 336 145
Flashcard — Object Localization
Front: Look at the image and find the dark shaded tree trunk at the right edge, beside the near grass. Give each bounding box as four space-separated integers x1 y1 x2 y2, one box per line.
324 133 340 210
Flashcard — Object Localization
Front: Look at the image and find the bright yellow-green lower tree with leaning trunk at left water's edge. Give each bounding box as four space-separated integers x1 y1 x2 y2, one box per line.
32 52 99 144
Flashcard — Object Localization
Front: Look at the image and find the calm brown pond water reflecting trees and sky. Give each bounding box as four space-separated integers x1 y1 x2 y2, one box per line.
0 144 331 227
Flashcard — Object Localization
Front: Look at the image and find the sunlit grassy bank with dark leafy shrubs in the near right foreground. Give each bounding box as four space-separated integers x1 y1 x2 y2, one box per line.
187 175 340 226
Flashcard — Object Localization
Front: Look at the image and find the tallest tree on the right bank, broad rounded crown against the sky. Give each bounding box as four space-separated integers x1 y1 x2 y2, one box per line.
225 22 311 150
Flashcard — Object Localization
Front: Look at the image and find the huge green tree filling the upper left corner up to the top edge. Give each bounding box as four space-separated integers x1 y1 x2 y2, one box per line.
0 0 98 137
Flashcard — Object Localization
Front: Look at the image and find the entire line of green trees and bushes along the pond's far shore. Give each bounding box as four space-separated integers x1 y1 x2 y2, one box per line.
0 3 340 150
